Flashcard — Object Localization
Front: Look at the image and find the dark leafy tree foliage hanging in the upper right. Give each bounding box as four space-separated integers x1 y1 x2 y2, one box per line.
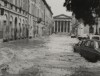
64 0 100 25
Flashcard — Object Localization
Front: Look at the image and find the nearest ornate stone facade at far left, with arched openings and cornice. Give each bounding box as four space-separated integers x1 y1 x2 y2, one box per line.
0 0 28 41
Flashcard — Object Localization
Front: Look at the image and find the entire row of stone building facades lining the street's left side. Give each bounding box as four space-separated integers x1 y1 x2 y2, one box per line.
0 0 53 41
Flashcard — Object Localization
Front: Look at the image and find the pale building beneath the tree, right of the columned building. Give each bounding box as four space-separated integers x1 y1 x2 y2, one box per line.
71 15 99 37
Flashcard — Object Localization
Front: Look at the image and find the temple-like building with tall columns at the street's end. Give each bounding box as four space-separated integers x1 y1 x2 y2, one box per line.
52 14 72 33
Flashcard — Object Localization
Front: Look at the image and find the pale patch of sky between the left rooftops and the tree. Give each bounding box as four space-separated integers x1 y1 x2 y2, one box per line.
46 0 71 16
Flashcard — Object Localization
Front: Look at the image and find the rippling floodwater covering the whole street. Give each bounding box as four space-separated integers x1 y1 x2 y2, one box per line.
0 35 100 76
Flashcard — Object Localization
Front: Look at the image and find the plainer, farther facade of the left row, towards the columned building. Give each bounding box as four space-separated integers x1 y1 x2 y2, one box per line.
29 0 53 37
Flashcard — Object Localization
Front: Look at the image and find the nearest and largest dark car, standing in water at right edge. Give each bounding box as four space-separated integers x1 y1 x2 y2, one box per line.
79 40 100 62
